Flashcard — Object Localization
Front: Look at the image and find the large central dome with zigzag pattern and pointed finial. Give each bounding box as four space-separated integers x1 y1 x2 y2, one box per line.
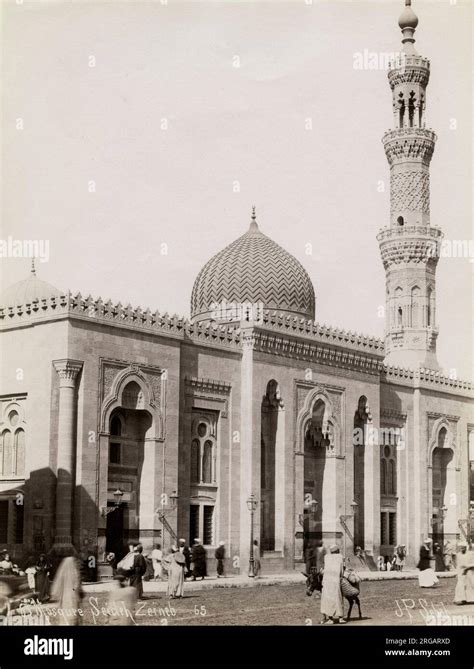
191 212 315 320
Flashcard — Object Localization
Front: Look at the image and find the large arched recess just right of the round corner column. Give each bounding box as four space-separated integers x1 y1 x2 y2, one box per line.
98 367 164 555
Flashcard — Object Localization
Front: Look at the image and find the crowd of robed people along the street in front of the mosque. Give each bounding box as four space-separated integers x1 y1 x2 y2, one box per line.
0 538 474 625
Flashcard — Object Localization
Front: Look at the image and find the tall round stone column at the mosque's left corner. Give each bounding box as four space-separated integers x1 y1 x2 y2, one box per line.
51 359 83 555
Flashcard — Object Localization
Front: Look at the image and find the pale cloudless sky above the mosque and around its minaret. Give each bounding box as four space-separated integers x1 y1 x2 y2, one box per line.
0 0 474 378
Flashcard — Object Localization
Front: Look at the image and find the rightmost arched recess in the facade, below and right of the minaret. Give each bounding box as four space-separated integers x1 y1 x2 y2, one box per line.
427 416 459 542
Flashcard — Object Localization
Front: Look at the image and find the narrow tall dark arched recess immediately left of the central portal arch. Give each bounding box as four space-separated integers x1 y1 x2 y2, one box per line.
260 379 285 551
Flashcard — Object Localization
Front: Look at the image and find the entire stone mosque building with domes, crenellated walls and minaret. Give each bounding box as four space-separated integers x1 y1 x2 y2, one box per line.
0 0 474 573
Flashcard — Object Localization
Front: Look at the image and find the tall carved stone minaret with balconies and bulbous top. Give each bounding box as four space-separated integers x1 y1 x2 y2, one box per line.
377 0 443 370
